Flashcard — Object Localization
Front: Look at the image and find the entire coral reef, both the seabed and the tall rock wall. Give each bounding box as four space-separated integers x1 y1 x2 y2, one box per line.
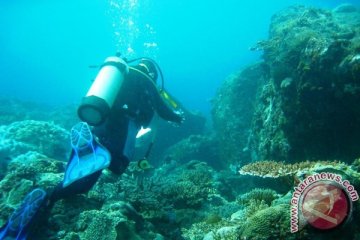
0 5 360 240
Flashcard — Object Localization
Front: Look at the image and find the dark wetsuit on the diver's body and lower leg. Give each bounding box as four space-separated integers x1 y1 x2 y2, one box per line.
49 67 182 203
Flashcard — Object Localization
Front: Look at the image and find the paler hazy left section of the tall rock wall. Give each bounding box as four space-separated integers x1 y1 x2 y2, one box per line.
212 63 266 166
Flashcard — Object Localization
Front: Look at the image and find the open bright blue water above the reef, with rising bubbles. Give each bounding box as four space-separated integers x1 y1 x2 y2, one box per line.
0 0 359 116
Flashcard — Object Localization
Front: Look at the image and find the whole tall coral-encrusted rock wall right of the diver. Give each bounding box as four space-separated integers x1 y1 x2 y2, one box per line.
213 5 360 163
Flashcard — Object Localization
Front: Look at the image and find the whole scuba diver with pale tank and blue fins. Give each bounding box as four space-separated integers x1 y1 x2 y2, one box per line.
0 56 184 240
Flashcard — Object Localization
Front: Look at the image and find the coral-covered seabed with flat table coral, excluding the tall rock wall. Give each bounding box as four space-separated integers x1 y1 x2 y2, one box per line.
0 142 360 240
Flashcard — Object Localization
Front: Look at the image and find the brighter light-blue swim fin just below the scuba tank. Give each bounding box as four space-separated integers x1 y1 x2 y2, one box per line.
63 122 111 187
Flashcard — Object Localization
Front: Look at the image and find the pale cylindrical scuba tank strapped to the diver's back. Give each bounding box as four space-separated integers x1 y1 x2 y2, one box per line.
77 57 129 126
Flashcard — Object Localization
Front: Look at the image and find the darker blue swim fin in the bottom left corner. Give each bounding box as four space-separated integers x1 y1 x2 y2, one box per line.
0 188 46 240
